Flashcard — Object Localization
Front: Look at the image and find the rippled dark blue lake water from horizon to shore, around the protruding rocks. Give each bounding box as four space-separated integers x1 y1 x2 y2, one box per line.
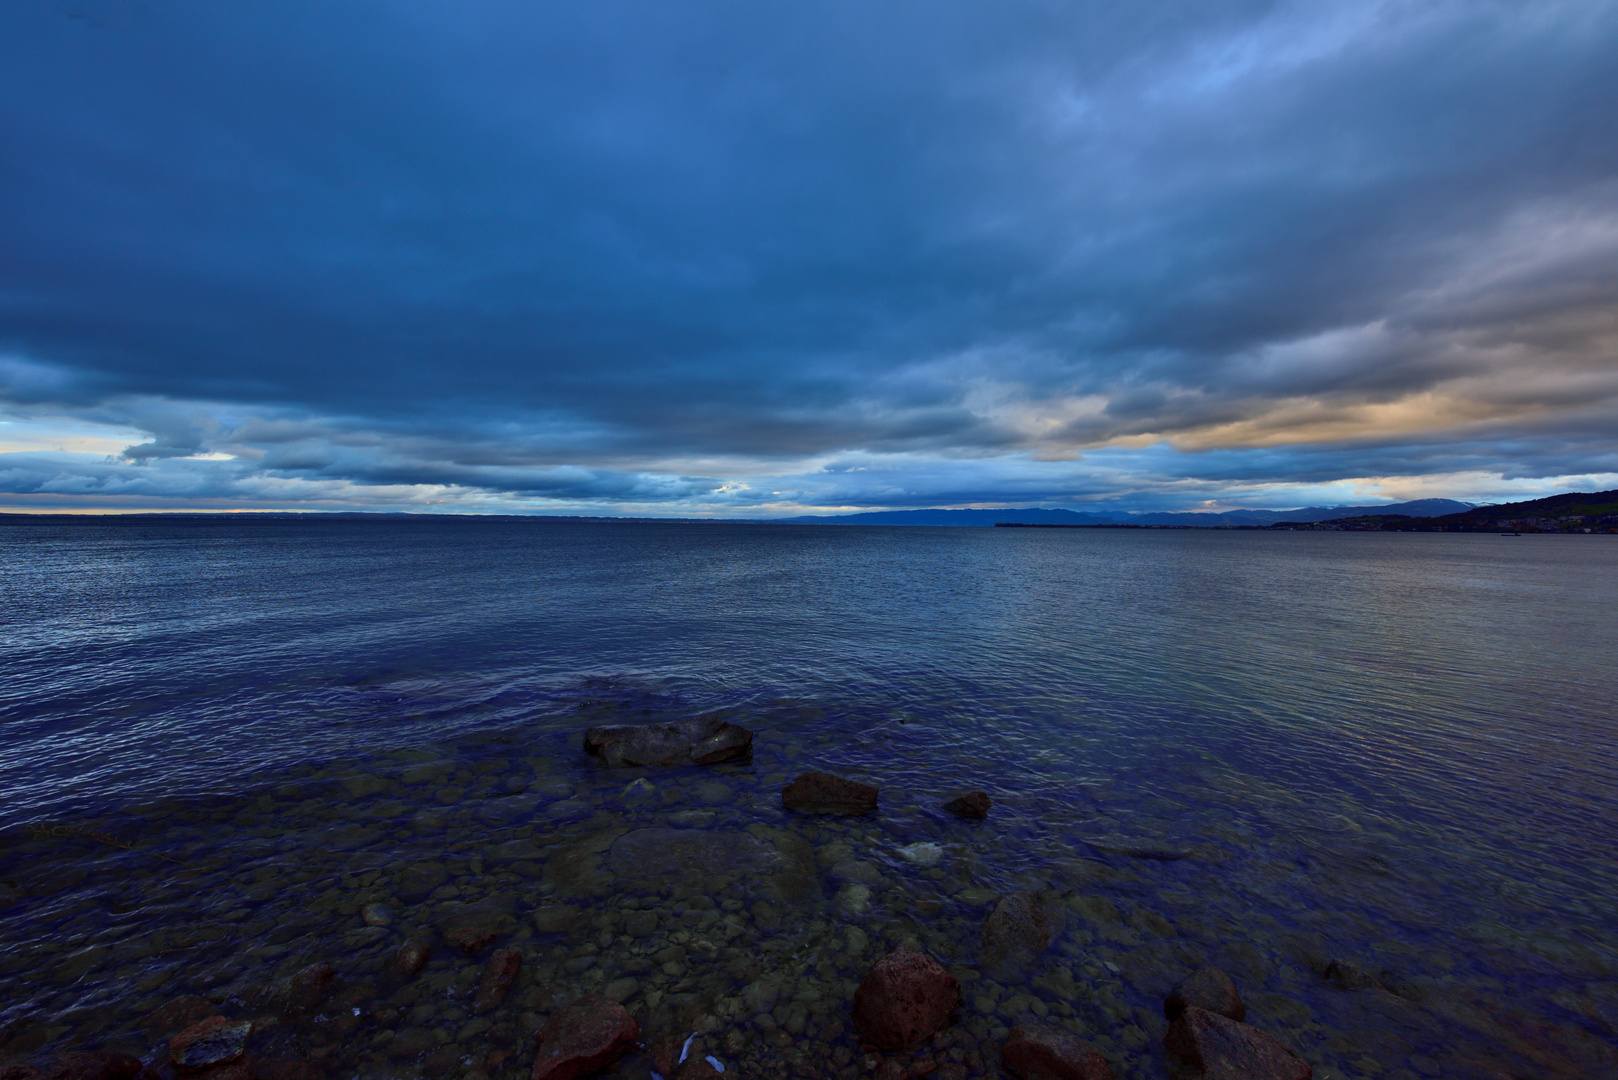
0 520 1618 1080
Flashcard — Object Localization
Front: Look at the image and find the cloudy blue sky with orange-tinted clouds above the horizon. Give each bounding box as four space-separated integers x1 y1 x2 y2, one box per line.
0 0 1618 517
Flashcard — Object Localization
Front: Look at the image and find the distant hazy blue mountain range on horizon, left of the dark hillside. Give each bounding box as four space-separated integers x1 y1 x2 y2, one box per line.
777 499 1474 528
